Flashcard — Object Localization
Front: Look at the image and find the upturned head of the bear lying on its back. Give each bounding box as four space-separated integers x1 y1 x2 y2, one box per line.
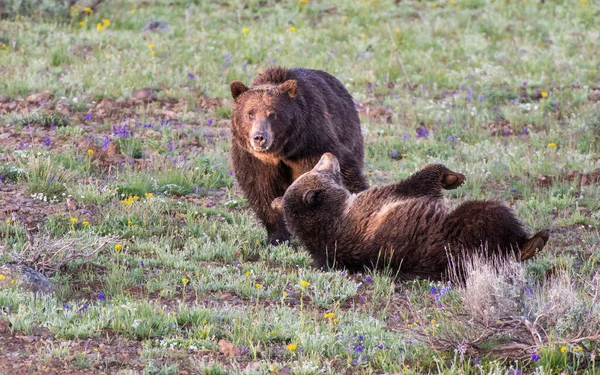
271 152 350 235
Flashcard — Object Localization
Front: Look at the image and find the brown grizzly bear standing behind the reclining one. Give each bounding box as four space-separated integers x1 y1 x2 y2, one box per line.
230 67 368 244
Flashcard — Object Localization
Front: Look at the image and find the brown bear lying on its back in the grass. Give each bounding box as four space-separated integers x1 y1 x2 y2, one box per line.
273 154 549 280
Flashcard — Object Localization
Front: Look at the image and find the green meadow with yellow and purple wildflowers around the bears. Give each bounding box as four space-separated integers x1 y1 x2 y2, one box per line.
0 0 600 375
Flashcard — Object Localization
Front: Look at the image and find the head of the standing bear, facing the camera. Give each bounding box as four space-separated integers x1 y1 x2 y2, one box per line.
230 80 297 155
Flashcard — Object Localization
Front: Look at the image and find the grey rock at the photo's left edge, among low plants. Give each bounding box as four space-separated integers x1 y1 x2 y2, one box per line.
0 263 56 294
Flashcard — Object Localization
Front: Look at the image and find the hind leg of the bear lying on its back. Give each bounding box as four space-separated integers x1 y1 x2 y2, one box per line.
444 201 549 260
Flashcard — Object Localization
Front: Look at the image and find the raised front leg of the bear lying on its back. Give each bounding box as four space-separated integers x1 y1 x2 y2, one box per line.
392 164 465 197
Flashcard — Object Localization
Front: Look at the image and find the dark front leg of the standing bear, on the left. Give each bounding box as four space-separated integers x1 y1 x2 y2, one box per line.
231 143 291 244
